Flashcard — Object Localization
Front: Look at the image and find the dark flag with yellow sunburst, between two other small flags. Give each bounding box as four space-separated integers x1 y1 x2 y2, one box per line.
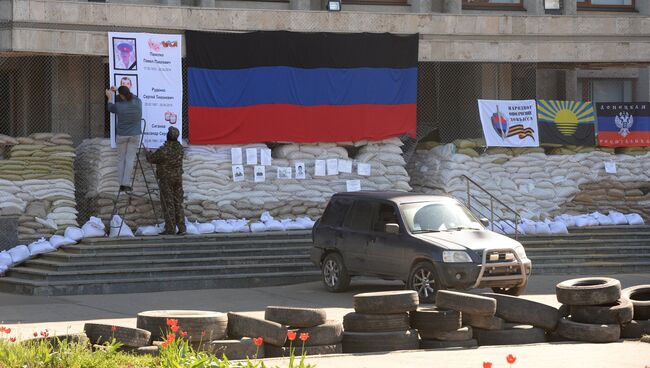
537 100 596 146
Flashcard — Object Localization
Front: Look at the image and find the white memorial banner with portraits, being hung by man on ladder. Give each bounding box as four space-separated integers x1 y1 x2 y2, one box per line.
108 32 183 148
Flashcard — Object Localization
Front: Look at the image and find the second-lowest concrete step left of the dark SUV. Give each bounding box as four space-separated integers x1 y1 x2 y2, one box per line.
24 251 309 271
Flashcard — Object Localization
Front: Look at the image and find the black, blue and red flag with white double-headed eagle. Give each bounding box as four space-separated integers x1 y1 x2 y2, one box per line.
596 102 650 147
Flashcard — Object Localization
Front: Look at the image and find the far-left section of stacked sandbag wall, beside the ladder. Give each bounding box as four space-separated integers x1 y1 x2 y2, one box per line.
0 133 77 239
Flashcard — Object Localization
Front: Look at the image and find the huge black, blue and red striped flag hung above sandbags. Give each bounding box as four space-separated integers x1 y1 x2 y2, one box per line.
185 31 418 144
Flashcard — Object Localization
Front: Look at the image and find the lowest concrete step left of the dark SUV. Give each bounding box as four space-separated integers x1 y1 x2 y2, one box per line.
0 270 320 296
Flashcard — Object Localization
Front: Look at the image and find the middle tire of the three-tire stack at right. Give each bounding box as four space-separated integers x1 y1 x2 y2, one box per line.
571 296 634 324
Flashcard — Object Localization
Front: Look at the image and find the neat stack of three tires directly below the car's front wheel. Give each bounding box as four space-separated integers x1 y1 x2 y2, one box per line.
343 290 419 353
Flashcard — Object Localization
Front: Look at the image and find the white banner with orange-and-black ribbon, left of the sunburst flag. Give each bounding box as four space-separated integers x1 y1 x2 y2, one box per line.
478 100 539 147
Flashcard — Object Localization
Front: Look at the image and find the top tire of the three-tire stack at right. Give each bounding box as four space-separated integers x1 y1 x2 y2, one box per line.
555 277 621 306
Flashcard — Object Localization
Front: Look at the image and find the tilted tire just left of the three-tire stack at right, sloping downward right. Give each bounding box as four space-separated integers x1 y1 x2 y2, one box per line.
481 293 559 331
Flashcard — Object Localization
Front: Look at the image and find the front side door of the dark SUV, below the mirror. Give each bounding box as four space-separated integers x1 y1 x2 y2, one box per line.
368 203 404 277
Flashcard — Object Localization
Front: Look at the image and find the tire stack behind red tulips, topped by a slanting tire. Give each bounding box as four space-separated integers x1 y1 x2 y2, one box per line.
264 306 343 358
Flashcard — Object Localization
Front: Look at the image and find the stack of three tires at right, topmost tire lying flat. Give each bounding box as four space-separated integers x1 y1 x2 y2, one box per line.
555 277 634 342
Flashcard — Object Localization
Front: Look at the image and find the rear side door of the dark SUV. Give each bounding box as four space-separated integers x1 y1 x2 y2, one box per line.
339 200 376 273
